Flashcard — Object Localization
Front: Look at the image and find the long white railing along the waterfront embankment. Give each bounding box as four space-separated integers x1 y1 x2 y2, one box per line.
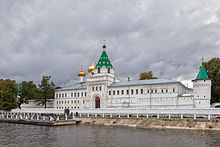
0 108 220 120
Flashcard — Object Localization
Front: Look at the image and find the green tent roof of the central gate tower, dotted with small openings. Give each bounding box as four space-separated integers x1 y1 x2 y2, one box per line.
95 50 112 69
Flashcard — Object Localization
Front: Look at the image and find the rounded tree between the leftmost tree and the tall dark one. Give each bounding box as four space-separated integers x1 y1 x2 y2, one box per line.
18 81 38 109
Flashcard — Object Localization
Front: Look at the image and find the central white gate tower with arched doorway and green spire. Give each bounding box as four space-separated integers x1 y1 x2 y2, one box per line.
86 41 115 108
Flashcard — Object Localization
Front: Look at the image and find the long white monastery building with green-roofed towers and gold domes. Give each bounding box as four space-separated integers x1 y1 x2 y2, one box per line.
55 44 211 109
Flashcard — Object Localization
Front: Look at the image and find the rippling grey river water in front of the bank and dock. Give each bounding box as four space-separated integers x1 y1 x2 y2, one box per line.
0 123 220 147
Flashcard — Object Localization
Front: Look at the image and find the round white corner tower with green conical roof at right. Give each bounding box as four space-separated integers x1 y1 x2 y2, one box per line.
192 59 211 108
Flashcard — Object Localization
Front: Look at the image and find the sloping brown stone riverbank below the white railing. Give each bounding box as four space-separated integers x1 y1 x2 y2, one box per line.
75 117 220 131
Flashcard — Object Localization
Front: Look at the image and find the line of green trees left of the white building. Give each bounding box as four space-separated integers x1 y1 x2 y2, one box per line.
0 76 56 110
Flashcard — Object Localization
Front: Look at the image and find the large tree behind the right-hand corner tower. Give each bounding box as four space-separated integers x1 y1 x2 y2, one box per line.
203 58 220 103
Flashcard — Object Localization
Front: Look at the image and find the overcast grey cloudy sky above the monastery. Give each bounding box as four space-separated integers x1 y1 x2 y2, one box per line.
0 0 220 86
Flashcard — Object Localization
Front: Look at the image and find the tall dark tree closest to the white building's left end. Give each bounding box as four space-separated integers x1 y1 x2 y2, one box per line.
36 76 55 109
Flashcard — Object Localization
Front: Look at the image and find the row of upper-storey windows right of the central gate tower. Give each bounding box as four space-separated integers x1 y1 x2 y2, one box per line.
109 89 175 95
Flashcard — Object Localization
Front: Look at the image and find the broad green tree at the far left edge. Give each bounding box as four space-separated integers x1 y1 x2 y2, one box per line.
0 79 17 110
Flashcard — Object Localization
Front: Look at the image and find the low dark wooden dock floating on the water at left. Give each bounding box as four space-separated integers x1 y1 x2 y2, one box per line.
0 118 80 126
